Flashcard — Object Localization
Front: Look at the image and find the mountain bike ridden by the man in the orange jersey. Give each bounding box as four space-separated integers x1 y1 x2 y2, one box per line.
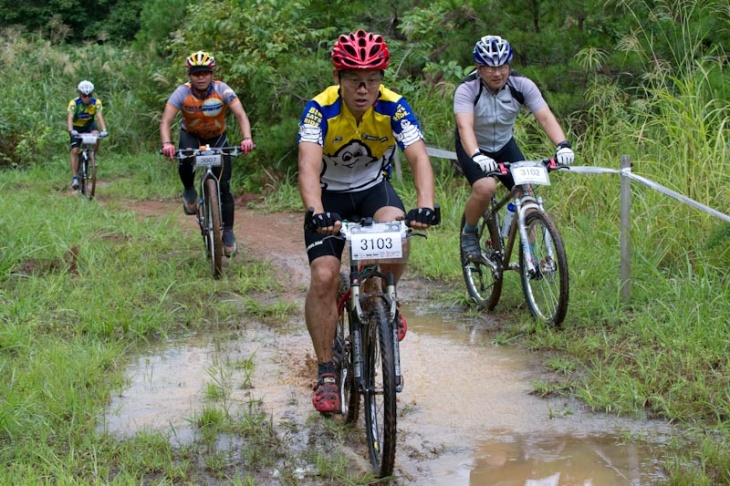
160 146 243 279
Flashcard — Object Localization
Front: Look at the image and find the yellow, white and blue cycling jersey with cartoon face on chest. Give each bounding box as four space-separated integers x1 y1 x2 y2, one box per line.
298 86 423 192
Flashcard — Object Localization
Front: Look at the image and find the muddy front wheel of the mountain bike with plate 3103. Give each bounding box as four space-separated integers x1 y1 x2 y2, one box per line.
363 299 397 477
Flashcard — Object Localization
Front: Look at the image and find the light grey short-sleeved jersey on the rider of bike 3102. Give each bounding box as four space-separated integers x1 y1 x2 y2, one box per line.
454 71 547 153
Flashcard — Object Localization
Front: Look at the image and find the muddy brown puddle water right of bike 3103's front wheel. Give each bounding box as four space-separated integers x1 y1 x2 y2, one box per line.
399 305 669 486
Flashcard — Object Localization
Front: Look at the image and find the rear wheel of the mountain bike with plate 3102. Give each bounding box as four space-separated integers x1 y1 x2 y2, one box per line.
459 215 502 311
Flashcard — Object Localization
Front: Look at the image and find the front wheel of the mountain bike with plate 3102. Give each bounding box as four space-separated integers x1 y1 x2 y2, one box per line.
520 211 569 326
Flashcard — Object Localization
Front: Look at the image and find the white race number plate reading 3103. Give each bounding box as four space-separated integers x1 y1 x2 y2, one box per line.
350 223 403 261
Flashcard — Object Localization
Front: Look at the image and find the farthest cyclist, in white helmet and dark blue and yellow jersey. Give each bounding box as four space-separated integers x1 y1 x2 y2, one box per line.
66 80 107 191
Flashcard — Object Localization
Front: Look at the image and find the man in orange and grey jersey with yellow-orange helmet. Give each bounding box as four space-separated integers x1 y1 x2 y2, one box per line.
160 51 254 257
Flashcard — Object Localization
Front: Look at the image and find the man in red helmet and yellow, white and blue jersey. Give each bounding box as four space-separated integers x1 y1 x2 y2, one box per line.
298 30 434 412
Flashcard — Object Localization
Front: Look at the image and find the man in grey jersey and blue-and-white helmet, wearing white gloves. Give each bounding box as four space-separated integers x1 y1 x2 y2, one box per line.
454 35 574 259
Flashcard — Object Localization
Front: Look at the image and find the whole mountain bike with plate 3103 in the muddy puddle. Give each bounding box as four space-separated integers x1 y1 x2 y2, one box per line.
305 206 441 477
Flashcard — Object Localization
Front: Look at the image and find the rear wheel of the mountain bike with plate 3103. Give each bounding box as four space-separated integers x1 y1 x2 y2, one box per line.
334 272 360 424
